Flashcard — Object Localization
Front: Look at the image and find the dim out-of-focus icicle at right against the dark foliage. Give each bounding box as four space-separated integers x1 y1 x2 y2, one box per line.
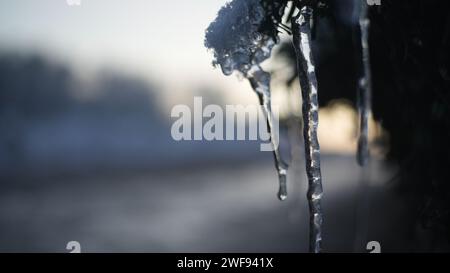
357 1 372 166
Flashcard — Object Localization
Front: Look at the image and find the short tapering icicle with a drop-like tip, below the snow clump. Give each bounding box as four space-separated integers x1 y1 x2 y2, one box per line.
247 65 288 201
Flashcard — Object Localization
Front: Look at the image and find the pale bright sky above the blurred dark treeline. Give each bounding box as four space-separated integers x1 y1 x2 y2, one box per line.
0 0 253 103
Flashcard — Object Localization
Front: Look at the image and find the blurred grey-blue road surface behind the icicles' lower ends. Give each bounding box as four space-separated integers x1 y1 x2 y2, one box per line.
0 155 414 252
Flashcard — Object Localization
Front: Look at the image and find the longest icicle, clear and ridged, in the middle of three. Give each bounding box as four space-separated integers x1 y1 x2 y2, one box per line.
292 6 323 253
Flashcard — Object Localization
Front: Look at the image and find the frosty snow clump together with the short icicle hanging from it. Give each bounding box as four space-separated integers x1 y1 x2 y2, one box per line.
205 0 288 200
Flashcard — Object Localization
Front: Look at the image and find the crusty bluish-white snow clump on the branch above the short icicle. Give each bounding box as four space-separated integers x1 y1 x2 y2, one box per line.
205 0 277 77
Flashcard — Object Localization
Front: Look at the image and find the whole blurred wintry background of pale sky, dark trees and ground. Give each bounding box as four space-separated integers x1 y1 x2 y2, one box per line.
0 0 444 252
